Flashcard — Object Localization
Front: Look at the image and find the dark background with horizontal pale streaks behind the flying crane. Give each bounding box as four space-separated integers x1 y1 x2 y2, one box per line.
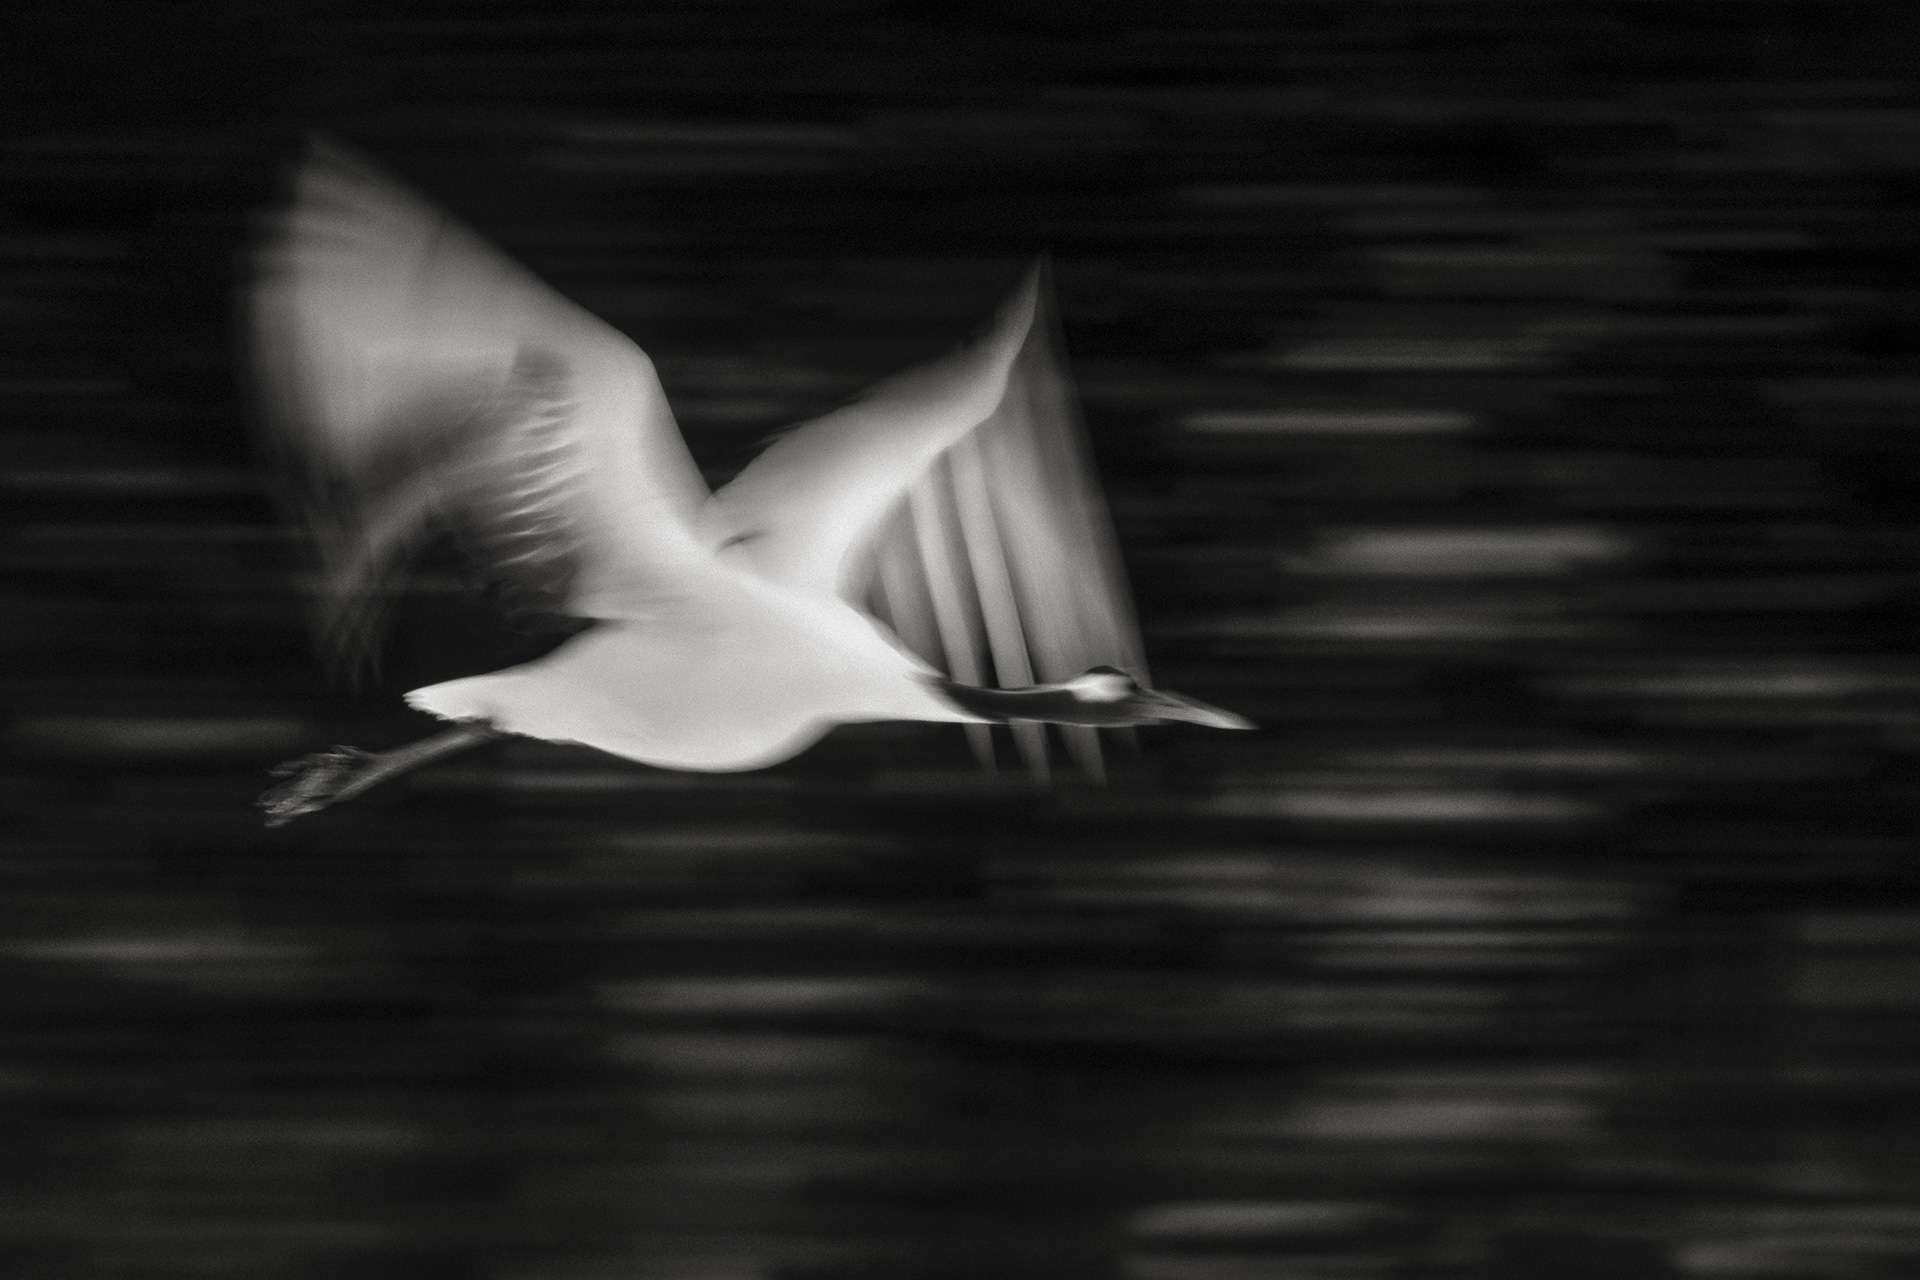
11 0 1920 1280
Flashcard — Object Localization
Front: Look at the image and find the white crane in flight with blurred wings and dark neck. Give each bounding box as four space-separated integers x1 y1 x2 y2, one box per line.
246 140 1252 825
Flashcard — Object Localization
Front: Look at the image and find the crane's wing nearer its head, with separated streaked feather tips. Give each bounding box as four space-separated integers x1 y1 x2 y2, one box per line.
703 265 1148 777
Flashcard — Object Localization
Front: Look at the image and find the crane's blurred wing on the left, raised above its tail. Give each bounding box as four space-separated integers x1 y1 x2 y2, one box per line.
248 142 707 679
